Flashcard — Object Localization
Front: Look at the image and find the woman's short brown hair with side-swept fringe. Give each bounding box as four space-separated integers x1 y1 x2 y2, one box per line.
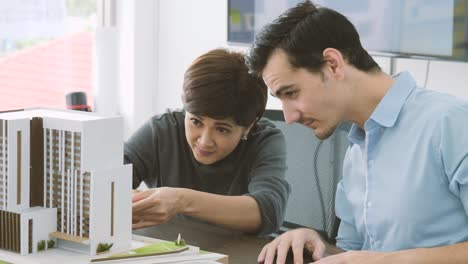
182 49 267 127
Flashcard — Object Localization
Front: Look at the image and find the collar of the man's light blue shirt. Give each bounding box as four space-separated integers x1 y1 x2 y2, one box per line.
348 72 416 144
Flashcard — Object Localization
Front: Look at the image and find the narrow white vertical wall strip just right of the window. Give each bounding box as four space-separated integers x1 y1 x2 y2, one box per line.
117 0 159 138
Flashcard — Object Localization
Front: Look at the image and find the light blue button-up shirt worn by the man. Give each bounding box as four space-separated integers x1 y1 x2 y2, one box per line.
335 73 468 251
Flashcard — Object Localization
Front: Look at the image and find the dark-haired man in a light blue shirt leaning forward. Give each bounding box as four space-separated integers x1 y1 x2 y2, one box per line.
247 1 468 264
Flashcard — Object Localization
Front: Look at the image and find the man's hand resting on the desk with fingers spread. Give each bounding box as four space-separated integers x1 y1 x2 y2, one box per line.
257 228 326 264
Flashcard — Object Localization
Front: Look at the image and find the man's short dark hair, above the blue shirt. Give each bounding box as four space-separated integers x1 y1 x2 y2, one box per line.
246 1 380 76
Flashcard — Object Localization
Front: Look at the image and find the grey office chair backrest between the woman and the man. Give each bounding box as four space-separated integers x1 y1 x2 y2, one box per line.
264 110 350 243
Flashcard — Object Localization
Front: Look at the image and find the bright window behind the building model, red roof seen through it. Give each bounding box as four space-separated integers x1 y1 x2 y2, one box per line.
0 0 98 111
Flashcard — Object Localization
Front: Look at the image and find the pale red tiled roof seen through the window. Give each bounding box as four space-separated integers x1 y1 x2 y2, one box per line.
0 32 93 111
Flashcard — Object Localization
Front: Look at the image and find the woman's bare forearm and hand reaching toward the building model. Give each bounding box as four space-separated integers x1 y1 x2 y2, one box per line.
132 187 262 233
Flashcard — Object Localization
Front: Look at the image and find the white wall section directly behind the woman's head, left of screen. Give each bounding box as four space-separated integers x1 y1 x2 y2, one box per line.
155 0 227 112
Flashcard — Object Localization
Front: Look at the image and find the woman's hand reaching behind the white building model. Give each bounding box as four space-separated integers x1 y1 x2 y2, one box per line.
132 187 183 229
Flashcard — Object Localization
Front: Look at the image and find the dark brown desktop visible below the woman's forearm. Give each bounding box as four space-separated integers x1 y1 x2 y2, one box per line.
133 217 269 264
